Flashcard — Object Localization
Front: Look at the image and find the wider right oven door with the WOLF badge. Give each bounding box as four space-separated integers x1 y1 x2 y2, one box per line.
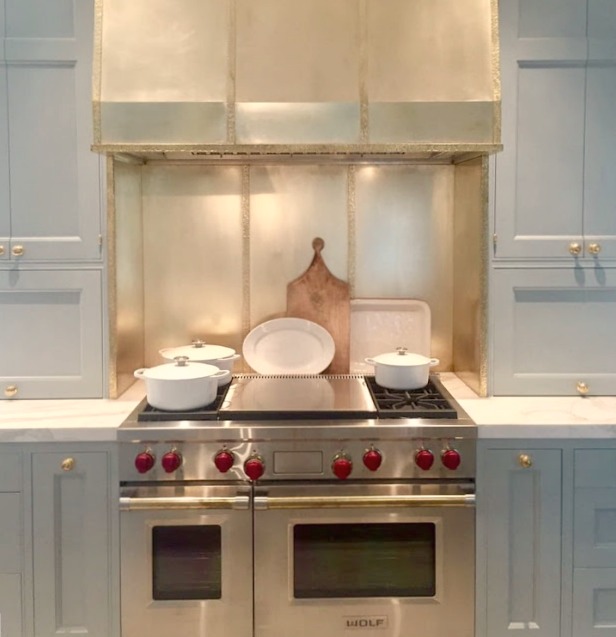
254 483 475 637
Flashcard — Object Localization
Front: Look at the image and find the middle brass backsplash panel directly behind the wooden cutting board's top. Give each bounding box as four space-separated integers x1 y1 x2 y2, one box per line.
250 165 348 327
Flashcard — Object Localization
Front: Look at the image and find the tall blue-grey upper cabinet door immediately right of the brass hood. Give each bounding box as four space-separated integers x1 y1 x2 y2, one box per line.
495 0 586 259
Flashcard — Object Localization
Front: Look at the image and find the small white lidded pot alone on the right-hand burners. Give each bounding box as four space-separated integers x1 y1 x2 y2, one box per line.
365 347 439 389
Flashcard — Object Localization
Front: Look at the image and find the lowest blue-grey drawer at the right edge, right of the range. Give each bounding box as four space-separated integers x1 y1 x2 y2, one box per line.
573 568 616 637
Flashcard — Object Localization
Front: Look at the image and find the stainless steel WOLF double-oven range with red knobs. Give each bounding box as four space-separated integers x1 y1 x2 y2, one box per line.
118 375 476 637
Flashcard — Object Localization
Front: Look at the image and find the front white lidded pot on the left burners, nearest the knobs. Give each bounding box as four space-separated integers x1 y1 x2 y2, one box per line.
134 356 231 411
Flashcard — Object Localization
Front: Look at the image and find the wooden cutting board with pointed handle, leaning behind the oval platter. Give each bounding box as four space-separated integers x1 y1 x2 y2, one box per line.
287 237 351 374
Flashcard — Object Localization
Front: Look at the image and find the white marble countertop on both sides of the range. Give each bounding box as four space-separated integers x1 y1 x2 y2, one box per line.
0 373 616 442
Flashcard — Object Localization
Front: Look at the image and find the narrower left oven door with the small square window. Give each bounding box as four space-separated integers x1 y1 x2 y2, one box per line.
120 485 252 637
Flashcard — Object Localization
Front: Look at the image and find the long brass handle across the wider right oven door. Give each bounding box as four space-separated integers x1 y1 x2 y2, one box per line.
254 493 475 510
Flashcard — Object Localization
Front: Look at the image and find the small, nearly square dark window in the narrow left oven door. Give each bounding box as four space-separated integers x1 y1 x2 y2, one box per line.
152 525 222 600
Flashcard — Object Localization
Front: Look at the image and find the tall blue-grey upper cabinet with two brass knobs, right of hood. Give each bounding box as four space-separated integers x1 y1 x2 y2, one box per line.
494 0 616 265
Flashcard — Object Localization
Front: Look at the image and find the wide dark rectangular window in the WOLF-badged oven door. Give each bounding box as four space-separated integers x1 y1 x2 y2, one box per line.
293 523 436 599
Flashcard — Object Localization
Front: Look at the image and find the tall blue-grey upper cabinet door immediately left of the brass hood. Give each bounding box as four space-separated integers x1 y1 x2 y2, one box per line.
0 0 101 261
